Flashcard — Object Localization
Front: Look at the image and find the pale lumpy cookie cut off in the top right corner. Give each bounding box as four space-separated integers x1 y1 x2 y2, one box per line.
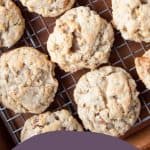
112 0 150 42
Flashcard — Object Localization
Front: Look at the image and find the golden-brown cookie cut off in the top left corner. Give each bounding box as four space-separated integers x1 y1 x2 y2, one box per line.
0 0 25 48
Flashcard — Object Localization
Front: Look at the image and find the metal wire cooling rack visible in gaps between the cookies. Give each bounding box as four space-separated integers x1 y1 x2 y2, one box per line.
0 0 150 144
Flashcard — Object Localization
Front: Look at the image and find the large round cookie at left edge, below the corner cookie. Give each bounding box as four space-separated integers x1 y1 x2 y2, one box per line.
0 47 58 114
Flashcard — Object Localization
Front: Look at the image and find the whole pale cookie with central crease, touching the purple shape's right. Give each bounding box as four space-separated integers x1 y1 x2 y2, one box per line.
74 66 141 136
